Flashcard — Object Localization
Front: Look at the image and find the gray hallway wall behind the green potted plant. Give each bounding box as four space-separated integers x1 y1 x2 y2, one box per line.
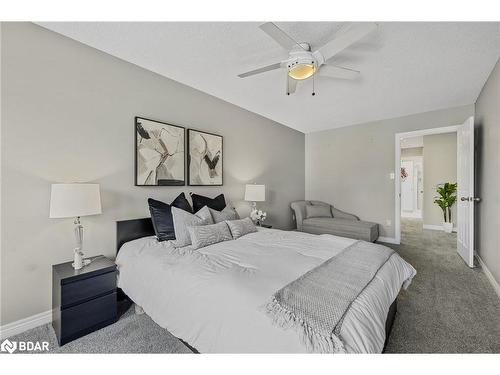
422 132 457 227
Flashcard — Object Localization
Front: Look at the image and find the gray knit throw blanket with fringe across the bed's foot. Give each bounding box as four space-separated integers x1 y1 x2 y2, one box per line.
265 241 394 353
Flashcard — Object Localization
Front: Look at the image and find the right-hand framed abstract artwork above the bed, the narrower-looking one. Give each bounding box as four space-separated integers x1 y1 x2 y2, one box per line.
188 129 223 186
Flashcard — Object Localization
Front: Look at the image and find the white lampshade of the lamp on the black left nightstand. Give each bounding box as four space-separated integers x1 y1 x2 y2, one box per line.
49 184 102 218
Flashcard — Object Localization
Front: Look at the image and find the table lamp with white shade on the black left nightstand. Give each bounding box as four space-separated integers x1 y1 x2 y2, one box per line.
49 184 102 270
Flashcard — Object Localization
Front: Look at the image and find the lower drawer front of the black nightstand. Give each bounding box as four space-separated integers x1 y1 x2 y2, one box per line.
61 292 117 342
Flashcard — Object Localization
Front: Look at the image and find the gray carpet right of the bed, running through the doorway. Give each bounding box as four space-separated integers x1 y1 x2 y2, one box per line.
386 219 500 353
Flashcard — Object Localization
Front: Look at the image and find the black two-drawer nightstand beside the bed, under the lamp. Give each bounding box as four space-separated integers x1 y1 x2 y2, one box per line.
52 256 117 345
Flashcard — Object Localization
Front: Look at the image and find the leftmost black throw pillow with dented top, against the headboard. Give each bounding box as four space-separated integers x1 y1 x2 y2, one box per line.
148 193 193 241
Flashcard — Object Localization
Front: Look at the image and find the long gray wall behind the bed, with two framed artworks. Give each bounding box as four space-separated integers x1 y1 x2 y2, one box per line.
1 23 304 324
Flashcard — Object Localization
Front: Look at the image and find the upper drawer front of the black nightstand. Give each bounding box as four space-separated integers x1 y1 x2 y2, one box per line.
61 271 116 308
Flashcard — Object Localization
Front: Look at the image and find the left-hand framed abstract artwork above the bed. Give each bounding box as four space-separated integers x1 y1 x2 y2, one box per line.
135 117 186 186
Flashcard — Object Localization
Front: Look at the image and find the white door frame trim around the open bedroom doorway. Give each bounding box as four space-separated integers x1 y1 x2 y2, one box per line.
394 124 462 244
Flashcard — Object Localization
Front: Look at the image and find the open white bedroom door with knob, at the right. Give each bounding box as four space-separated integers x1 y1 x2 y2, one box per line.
457 117 476 267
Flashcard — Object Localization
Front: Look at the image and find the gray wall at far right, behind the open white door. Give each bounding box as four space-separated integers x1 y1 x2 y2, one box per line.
475 58 500 284
